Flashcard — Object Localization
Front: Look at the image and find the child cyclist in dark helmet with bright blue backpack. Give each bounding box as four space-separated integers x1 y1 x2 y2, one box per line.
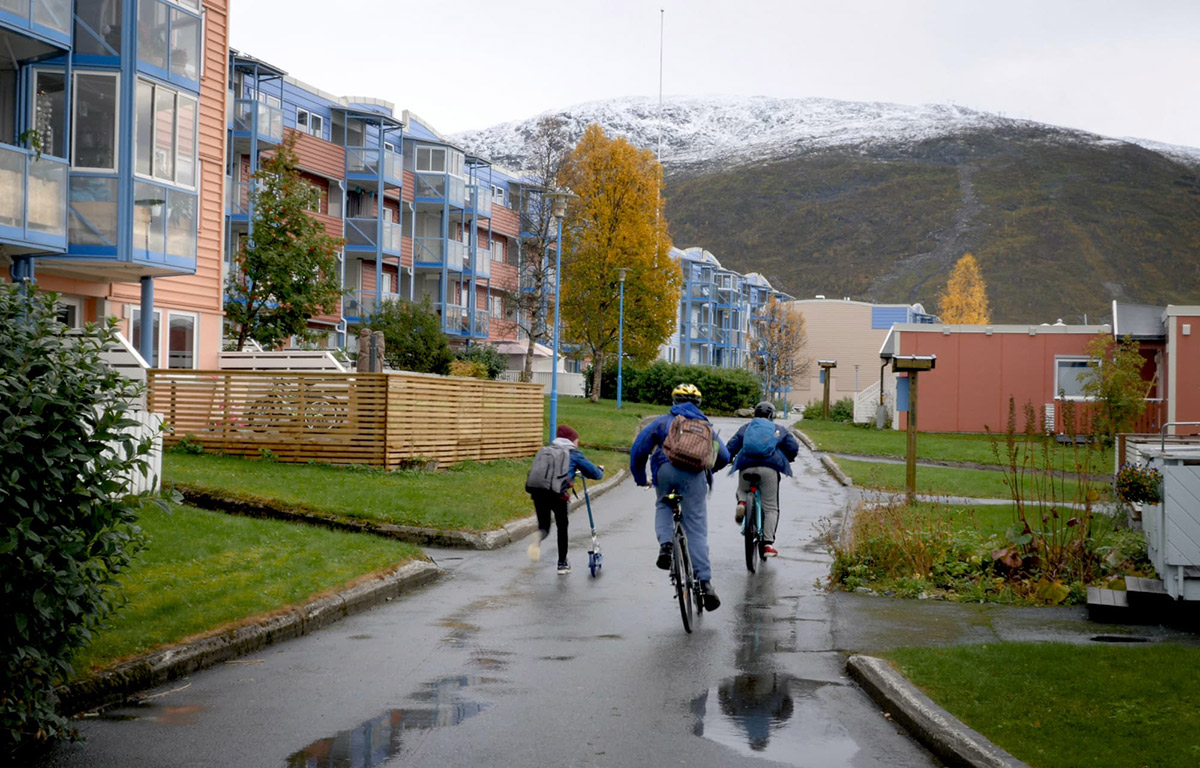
728 401 800 557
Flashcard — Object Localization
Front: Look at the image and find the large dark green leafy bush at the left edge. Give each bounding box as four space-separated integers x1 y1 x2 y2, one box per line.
0 286 151 751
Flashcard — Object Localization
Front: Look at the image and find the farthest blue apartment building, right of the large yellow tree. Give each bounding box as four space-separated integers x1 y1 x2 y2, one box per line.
659 247 791 368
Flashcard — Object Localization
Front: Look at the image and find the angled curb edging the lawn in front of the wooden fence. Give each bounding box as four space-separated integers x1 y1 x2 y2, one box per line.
175 468 629 550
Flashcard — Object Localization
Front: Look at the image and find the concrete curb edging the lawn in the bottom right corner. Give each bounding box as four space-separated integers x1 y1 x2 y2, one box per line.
846 655 1028 768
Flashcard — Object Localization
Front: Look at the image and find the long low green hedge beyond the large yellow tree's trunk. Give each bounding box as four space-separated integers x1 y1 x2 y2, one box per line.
584 360 762 413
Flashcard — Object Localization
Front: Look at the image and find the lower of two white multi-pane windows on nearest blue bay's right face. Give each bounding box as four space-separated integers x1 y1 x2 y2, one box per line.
133 79 197 187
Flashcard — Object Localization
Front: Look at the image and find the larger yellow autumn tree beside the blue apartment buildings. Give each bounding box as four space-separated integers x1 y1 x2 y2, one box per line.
562 125 683 401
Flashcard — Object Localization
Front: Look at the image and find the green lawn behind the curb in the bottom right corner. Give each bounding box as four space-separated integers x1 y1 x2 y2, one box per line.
883 643 1200 768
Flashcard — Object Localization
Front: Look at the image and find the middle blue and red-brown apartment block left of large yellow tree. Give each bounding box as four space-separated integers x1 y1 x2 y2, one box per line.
226 52 520 347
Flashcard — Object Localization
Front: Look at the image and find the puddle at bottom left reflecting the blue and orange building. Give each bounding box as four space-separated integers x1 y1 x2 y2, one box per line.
287 674 499 768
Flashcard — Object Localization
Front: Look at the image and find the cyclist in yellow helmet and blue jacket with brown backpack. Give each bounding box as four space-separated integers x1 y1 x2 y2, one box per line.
629 384 730 611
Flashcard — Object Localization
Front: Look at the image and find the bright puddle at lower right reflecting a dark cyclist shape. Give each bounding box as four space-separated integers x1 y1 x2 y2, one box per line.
691 672 858 766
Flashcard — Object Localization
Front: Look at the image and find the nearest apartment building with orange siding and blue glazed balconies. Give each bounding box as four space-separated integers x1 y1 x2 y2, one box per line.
0 0 228 367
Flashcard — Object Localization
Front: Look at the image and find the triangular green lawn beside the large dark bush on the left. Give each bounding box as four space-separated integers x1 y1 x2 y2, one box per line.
76 505 424 674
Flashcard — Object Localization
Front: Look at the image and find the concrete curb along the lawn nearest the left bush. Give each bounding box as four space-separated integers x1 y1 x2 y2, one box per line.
55 560 443 715
